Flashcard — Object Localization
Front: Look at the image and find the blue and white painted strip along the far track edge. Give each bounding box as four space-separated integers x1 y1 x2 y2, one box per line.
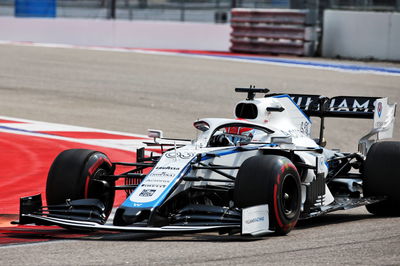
195 54 400 75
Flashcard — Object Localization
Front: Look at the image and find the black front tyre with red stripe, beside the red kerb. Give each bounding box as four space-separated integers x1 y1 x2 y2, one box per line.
46 149 115 217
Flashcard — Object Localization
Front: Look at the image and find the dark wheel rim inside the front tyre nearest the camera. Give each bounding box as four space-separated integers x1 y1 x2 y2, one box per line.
280 175 299 219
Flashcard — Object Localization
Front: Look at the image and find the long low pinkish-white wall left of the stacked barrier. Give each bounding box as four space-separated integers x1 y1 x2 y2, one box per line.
0 17 231 51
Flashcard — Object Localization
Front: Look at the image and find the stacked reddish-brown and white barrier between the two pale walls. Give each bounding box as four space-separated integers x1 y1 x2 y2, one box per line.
230 8 317 56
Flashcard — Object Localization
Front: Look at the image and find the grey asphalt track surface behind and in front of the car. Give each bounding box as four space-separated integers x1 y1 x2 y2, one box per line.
0 45 400 265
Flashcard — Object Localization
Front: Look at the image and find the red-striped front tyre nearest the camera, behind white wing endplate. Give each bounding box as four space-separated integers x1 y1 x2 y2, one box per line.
233 155 301 235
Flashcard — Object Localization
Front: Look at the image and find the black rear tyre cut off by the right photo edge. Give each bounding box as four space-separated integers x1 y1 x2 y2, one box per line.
363 141 400 216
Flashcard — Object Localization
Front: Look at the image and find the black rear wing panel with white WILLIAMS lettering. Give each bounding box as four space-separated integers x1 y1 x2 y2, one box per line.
289 94 382 119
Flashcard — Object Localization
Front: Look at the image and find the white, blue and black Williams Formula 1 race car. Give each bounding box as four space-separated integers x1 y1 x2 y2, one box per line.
18 86 400 235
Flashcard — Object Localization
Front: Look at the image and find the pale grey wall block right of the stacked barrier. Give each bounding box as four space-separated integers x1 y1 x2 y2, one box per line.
322 10 400 61
